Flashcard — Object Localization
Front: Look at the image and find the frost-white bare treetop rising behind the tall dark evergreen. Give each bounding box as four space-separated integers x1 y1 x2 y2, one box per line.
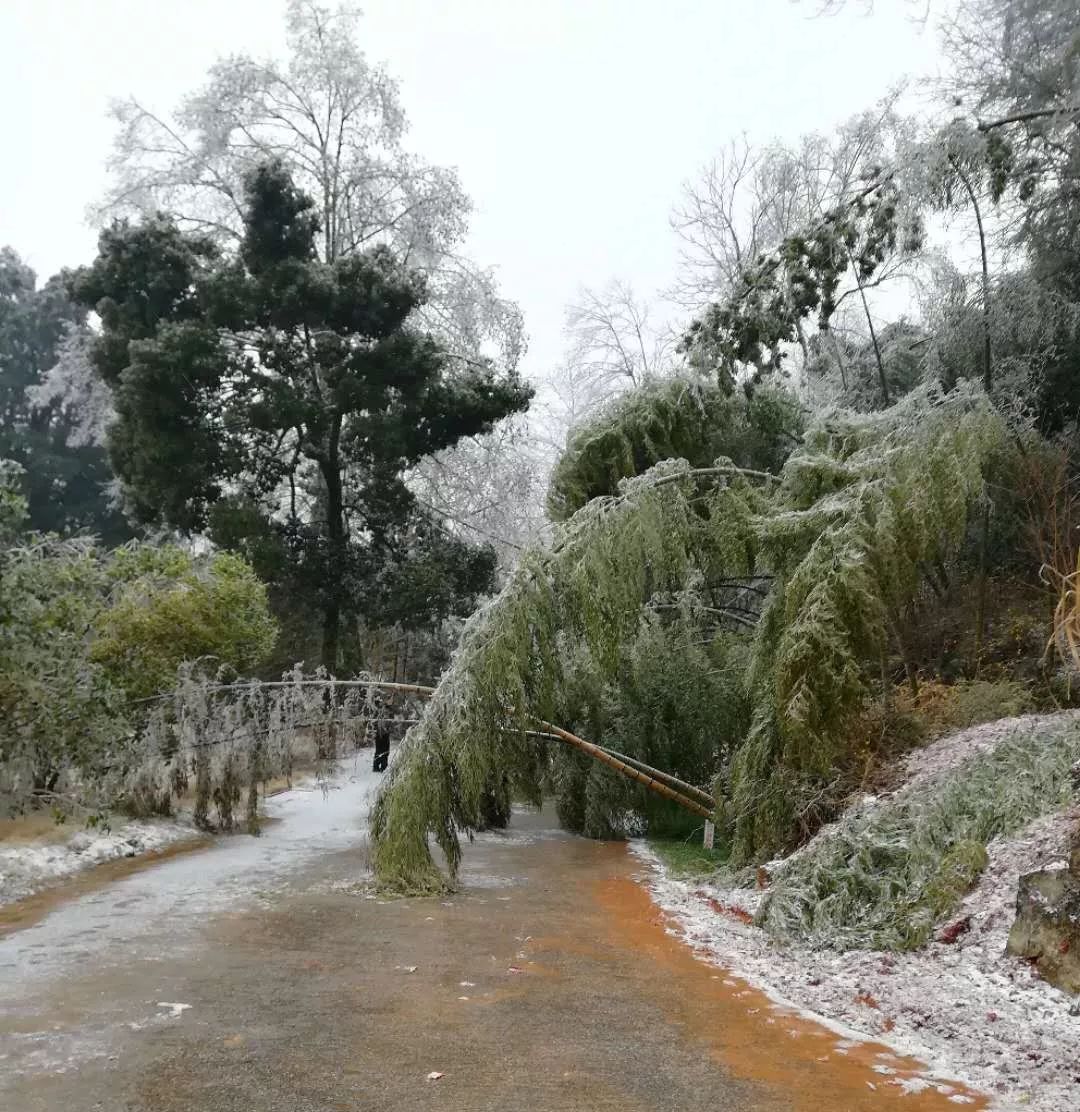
91 0 523 366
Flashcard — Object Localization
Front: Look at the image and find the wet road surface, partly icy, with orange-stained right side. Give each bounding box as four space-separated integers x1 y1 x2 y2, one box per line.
0 768 981 1112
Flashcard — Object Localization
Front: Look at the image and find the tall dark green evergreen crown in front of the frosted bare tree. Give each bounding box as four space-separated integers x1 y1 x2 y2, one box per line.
71 162 532 671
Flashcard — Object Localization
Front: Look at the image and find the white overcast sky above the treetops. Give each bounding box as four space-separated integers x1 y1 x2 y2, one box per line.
0 0 937 374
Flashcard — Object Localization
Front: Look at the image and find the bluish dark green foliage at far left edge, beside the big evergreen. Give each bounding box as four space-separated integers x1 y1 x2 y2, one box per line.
0 247 131 542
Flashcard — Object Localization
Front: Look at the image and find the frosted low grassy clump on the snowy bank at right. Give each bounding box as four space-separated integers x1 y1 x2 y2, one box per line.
759 716 1080 950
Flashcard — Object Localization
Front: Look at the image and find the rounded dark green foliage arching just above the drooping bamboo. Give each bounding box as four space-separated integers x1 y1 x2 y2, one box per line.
547 378 802 522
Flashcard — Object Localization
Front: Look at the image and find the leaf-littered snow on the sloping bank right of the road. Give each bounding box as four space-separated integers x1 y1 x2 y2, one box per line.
633 717 1080 1112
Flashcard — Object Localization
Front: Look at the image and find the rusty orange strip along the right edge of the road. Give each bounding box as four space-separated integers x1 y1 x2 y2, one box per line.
591 875 988 1112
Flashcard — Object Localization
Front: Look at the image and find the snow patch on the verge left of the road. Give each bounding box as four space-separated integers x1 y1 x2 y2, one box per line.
0 820 198 907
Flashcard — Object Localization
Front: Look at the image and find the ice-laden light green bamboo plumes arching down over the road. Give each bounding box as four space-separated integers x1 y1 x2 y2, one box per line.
373 386 1004 891
